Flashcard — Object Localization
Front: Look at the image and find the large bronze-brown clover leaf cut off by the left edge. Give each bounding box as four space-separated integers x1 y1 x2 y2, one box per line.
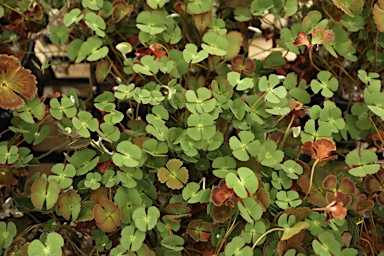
0 54 37 110
